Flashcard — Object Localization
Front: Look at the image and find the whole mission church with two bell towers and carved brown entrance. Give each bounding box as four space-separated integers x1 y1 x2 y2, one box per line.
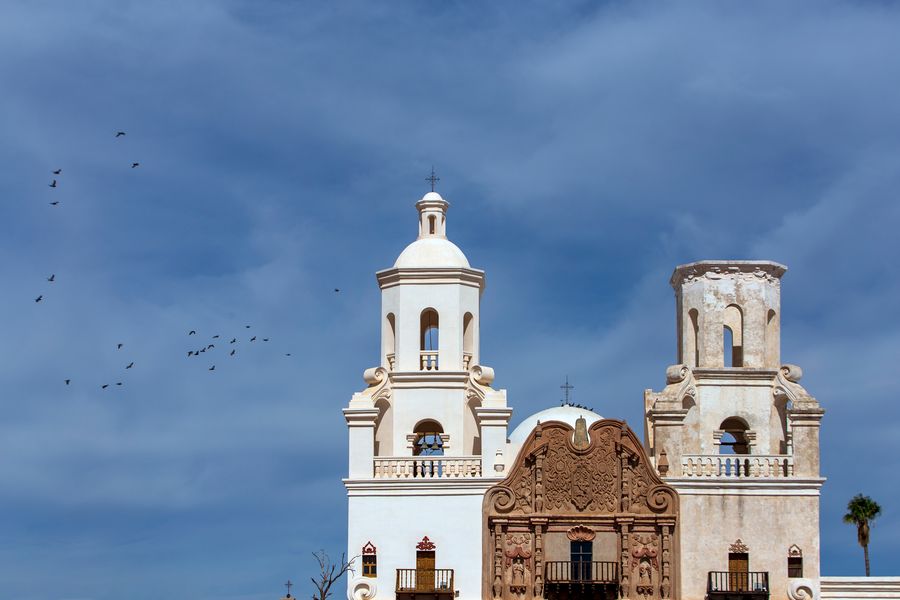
343 192 824 600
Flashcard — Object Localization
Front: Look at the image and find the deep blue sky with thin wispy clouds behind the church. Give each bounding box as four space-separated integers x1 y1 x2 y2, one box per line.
0 0 900 600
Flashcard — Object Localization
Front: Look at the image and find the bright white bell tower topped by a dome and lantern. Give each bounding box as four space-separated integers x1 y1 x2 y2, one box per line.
343 191 512 600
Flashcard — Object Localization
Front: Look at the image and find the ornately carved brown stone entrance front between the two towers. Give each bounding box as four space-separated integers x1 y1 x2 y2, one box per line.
482 419 679 600
